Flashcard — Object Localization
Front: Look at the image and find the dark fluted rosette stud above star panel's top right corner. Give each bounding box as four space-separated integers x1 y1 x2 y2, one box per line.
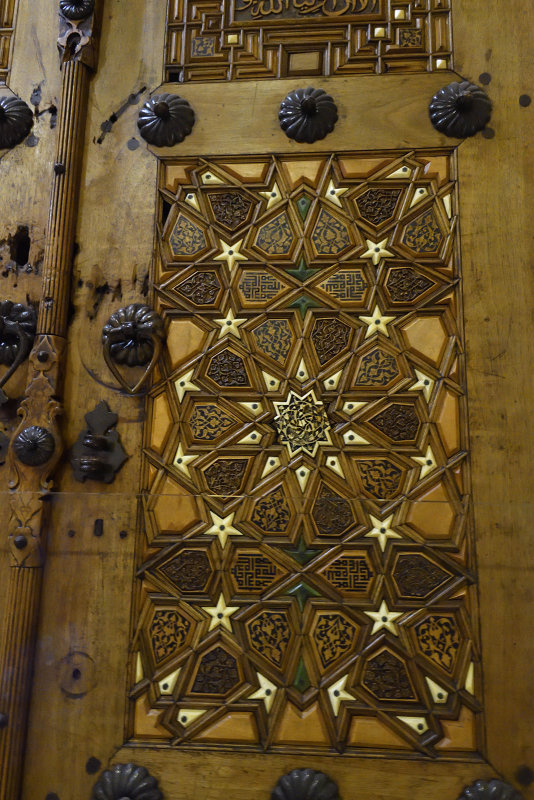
428 81 491 139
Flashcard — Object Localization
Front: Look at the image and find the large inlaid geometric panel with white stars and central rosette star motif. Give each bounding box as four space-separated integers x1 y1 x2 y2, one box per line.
130 151 482 758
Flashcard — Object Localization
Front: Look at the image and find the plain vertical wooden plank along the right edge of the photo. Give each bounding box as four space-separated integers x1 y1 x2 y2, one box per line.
454 0 534 797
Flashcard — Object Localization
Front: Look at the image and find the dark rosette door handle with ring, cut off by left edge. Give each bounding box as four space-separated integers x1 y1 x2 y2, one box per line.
0 300 37 405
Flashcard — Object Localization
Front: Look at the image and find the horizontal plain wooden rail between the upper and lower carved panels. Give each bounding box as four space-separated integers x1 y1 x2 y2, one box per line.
150 71 455 158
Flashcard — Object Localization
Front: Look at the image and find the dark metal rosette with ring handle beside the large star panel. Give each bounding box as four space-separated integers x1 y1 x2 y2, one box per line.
102 303 165 394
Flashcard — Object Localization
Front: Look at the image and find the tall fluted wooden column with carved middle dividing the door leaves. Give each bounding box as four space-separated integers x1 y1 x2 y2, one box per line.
0 0 101 800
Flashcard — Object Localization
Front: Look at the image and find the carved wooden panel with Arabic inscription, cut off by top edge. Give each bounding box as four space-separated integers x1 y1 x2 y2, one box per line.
165 0 453 82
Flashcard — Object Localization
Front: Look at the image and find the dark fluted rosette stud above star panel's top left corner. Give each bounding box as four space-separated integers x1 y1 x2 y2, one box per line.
137 92 195 147
